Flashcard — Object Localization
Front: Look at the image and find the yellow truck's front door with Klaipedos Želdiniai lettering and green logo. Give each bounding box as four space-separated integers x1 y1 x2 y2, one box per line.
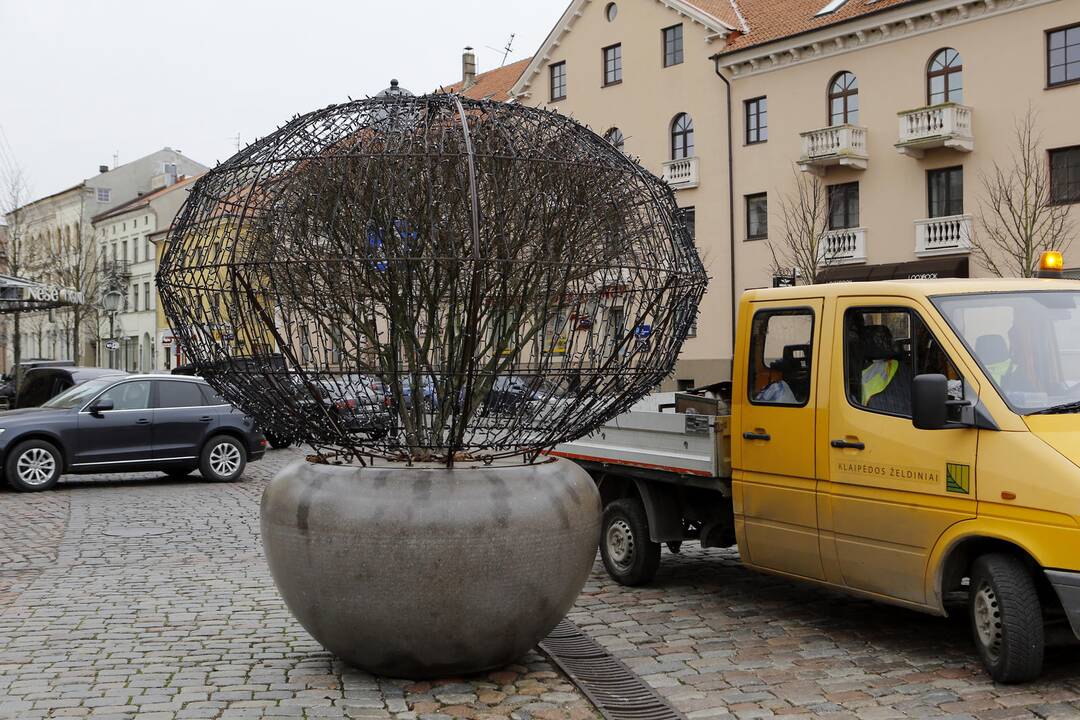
819 298 978 603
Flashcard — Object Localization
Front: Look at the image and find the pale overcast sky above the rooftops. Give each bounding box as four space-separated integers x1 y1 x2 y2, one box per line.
0 0 568 198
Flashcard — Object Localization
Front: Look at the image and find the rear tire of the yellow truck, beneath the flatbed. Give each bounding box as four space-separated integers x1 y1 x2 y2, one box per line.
600 498 660 586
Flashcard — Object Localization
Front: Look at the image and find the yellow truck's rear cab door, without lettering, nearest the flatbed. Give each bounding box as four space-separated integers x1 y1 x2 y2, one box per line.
733 298 824 580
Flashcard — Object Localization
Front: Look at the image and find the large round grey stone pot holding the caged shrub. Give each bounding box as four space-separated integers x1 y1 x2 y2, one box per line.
261 460 600 678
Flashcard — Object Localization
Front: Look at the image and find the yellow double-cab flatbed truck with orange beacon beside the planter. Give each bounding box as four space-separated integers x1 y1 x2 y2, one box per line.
553 274 1080 682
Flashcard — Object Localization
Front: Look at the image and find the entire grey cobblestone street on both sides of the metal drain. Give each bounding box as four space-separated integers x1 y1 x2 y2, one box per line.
0 450 1080 720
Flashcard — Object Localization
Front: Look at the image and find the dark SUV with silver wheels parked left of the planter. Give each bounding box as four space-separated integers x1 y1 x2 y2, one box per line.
0 375 266 491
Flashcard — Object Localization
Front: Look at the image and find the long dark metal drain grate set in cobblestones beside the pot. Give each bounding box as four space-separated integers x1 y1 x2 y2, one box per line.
540 620 686 720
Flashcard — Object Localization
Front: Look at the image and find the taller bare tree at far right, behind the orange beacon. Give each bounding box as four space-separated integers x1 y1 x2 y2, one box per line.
972 106 1072 277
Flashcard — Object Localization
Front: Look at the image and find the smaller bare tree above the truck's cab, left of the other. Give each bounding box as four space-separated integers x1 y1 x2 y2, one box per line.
769 169 835 283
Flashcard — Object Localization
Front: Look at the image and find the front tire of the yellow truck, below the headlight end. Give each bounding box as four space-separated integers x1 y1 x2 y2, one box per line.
968 554 1044 682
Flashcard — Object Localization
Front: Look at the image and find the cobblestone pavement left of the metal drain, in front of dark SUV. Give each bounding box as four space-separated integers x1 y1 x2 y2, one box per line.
0 450 597 720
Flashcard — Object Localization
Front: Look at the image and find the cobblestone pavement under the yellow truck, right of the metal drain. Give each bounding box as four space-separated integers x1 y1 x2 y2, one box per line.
570 543 1080 720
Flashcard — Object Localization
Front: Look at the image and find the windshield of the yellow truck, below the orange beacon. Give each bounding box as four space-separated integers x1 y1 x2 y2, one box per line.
931 290 1080 415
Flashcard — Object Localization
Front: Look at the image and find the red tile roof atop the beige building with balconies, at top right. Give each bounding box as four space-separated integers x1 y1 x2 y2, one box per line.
712 0 923 55
